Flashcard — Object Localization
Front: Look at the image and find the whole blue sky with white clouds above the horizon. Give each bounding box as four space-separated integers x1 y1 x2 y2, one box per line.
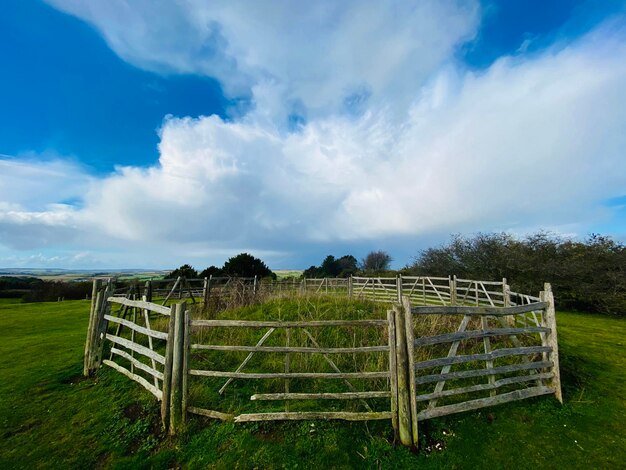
0 0 626 269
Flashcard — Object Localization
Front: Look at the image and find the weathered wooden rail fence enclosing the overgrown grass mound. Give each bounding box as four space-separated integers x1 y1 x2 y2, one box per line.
84 276 562 446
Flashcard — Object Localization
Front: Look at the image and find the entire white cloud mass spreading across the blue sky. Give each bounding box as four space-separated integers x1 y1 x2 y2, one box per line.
0 4 626 264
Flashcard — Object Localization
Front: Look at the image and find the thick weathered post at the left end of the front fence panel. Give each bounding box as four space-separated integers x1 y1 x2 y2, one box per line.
170 302 187 434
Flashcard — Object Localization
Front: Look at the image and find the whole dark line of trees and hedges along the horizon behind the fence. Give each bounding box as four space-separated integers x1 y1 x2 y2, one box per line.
0 232 626 315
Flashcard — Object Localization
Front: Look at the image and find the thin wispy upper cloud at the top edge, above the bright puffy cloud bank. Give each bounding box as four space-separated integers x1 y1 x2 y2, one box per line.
51 0 479 122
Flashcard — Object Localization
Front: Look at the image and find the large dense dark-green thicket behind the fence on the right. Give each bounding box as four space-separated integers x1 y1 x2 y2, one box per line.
404 232 626 315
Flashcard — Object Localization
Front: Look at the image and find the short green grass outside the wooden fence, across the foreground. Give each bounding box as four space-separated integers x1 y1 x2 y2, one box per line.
0 300 626 469
